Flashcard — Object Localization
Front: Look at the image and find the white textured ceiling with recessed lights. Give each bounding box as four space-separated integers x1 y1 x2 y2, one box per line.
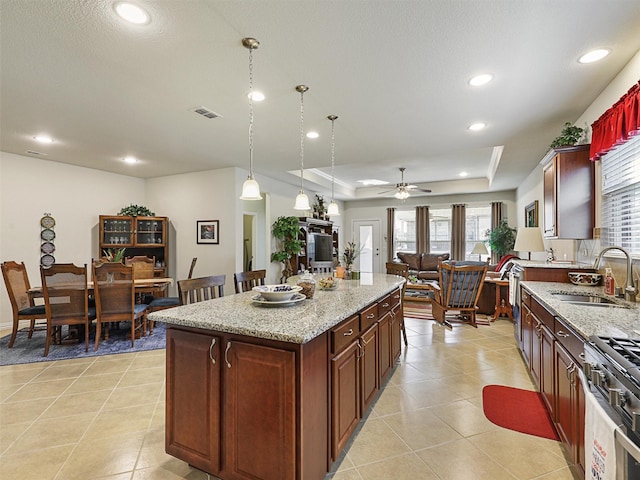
0 0 640 199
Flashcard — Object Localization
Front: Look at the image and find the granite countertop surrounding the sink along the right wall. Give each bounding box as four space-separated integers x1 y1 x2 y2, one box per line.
520 281 640 340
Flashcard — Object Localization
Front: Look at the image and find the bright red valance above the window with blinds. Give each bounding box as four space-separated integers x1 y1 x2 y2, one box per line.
590 81 640 160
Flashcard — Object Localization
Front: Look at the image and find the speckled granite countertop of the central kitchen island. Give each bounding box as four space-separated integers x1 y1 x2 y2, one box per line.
149 273 404 344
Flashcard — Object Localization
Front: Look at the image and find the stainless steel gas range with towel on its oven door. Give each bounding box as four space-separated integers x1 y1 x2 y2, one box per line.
580 337 640 480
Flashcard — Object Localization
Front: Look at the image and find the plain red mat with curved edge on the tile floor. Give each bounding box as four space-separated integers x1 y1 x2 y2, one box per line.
482 385 559 440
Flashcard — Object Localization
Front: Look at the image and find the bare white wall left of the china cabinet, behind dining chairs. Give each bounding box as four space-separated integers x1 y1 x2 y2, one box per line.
0 152 145 325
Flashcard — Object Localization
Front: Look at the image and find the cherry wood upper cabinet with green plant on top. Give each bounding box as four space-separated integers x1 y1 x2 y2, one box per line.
543 145 595 239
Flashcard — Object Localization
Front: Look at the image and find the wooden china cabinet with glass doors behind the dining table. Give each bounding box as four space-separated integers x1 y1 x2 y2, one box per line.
98 215 169 277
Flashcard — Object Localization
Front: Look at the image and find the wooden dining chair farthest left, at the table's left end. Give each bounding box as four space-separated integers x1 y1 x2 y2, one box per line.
1 261 47 348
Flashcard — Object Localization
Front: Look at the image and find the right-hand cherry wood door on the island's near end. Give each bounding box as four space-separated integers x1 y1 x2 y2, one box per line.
222 341 296 480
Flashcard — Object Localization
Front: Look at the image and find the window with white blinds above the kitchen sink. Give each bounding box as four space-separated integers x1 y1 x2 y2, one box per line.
600 136 640 256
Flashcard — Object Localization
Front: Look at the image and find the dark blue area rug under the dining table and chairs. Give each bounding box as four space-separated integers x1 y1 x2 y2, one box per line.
0 322 166 365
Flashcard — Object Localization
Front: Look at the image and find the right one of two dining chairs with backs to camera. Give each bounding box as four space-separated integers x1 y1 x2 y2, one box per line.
92 263 147 350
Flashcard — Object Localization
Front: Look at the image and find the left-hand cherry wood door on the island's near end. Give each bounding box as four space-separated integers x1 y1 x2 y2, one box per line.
165 329 220 474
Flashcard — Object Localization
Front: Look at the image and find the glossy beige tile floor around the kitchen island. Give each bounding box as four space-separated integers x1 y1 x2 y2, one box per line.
0 319 572 480
